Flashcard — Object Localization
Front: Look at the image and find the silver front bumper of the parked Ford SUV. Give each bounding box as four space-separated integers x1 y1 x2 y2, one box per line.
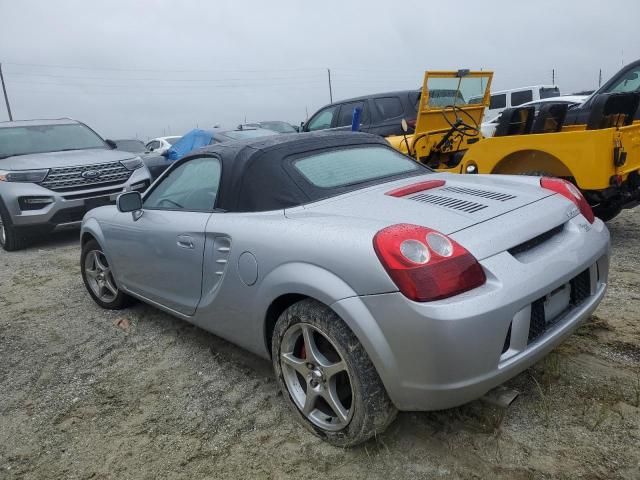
1 168 151 232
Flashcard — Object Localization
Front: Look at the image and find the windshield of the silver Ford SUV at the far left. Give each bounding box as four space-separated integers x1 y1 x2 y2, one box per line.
0 124 107 158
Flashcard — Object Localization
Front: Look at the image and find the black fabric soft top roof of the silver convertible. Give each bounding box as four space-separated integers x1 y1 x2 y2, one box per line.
180 131 425 212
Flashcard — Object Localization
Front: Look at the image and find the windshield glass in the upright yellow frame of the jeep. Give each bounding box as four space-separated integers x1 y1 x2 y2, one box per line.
427 76 489 108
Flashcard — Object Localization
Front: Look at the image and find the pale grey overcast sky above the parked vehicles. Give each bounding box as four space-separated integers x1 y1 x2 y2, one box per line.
0 0 640 140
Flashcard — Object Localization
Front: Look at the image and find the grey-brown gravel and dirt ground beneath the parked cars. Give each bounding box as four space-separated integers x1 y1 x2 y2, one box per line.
0 209 640 480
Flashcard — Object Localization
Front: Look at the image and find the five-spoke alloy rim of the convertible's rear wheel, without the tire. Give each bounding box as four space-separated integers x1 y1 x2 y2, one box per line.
280 323 353 431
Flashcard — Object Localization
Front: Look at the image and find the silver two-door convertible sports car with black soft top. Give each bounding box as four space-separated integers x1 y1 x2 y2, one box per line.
81 132 609 446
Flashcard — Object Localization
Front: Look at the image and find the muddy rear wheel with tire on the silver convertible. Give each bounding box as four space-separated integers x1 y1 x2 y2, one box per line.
272 299 397 447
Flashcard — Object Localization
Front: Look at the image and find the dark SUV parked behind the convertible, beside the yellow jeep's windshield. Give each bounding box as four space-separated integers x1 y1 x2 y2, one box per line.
302 90 421 137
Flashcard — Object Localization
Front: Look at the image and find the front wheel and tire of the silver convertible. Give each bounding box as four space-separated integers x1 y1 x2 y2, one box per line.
80 240 131 310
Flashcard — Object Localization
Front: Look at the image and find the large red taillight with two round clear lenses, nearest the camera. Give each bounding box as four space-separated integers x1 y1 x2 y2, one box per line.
373 223 486 302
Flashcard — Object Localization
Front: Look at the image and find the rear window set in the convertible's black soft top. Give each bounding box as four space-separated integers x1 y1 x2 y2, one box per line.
293 147 421 188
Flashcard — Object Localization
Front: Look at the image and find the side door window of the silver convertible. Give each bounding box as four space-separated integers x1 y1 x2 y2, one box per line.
143 157 221 212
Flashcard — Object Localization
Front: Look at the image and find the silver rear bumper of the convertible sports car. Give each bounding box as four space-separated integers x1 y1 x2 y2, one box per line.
332 220 609 410
